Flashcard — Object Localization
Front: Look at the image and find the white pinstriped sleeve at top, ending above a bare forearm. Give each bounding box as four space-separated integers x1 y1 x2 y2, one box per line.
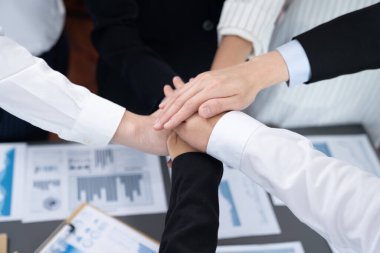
218 0 285 55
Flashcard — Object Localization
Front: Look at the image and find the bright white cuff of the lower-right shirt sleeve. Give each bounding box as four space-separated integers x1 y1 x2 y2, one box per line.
207 111 263 169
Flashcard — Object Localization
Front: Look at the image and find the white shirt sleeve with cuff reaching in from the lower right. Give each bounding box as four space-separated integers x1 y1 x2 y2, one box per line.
207 112 380 253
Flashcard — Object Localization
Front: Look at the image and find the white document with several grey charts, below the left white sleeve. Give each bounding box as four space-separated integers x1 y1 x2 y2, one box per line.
24 144 167 222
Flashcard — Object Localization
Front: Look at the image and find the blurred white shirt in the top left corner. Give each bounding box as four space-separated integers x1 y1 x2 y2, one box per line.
0 0 65 56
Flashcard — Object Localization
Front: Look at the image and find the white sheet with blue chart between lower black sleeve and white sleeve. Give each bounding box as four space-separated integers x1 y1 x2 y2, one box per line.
219 168 281 239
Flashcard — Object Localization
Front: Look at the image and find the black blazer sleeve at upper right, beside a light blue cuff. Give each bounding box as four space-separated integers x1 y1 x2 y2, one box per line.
295 3 380 83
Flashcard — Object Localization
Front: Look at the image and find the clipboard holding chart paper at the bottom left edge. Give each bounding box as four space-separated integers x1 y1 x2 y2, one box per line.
35 204 159 253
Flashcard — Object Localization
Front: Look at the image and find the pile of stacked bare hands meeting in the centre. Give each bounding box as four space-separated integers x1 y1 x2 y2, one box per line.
113 51 288 157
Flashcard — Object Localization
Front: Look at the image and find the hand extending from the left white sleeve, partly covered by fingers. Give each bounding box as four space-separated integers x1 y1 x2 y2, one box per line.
112 111 170 155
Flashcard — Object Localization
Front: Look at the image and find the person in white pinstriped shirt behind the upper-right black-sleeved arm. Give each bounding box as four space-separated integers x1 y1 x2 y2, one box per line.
156 0 380 147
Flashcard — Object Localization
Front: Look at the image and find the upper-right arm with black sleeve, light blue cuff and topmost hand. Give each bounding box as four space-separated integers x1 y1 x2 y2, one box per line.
155 3 380 129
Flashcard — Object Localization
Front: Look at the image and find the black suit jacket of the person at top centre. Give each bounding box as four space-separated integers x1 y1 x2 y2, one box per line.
86 0 224 114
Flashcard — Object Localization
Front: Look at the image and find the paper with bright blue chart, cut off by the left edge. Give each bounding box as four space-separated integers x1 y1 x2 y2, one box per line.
0 144 26 221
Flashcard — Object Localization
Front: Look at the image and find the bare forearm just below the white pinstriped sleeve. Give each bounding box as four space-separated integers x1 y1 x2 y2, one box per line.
211 35 252 70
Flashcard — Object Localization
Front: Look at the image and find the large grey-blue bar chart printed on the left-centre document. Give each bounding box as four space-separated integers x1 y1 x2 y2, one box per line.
74 174 152 208
